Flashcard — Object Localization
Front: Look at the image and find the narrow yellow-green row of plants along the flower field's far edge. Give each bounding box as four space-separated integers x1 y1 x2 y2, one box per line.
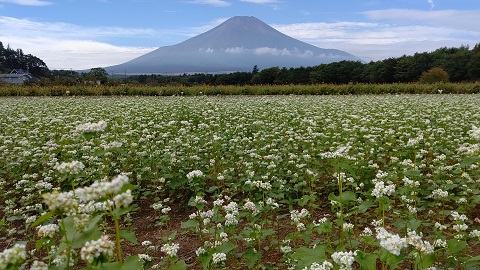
0 83 480 96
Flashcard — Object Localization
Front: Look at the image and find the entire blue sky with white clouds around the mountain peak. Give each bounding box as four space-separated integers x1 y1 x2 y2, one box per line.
0 0 480 69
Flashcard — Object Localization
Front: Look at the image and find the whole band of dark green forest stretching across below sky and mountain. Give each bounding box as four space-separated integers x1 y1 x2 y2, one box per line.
0 39 480 85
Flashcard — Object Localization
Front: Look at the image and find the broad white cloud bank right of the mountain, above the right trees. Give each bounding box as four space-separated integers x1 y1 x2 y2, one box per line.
272 9 480 61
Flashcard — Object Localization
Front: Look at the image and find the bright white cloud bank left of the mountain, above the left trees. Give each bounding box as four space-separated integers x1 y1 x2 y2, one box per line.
0 17 155 69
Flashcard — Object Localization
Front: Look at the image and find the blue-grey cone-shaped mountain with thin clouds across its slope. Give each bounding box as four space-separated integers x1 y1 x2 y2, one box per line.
105 16 360 74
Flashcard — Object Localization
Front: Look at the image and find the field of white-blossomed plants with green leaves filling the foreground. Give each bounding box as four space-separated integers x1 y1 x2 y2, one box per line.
0 94 480 270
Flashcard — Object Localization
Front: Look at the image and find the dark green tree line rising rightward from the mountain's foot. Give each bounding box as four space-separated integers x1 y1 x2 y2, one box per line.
124 44 480 85
